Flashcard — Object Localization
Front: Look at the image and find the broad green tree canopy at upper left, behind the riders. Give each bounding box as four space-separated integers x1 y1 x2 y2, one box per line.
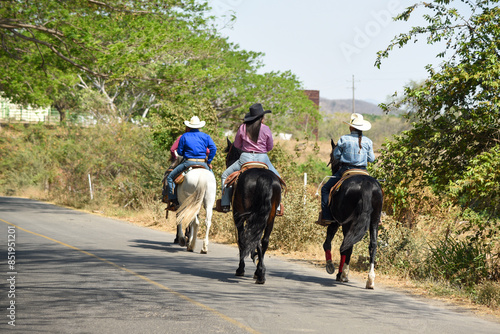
0 0 318 128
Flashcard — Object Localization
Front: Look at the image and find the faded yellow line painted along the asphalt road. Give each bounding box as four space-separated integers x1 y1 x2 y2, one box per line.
0 219 259 334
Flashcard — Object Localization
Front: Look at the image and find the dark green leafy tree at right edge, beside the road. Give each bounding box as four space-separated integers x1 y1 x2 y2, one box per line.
376 0 500 218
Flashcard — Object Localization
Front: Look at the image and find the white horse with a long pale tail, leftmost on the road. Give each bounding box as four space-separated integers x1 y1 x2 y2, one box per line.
176 168 217 254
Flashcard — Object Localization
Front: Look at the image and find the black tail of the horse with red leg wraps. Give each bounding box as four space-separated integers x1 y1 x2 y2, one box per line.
340 180 373 252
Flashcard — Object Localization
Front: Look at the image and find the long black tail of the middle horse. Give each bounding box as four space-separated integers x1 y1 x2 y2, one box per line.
235 174 281 257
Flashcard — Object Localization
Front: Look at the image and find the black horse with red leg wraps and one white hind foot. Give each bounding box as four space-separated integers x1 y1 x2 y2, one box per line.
323 140 383 289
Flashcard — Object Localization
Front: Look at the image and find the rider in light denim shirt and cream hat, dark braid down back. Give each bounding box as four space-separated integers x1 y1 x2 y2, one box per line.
317 113 375 225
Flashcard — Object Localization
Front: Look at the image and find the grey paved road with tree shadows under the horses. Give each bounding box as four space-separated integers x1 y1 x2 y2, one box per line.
0 197 500 334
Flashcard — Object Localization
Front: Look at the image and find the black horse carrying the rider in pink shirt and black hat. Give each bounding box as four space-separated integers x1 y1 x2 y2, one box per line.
225 139 282 284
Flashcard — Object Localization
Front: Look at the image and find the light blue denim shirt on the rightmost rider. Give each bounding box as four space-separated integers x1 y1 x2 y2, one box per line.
333 131 375 167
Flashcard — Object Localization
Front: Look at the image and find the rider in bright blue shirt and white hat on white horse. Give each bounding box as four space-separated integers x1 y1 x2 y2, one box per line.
167 116 217 211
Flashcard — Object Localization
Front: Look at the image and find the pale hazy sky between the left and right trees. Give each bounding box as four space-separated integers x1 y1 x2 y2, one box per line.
209 0 452 103
